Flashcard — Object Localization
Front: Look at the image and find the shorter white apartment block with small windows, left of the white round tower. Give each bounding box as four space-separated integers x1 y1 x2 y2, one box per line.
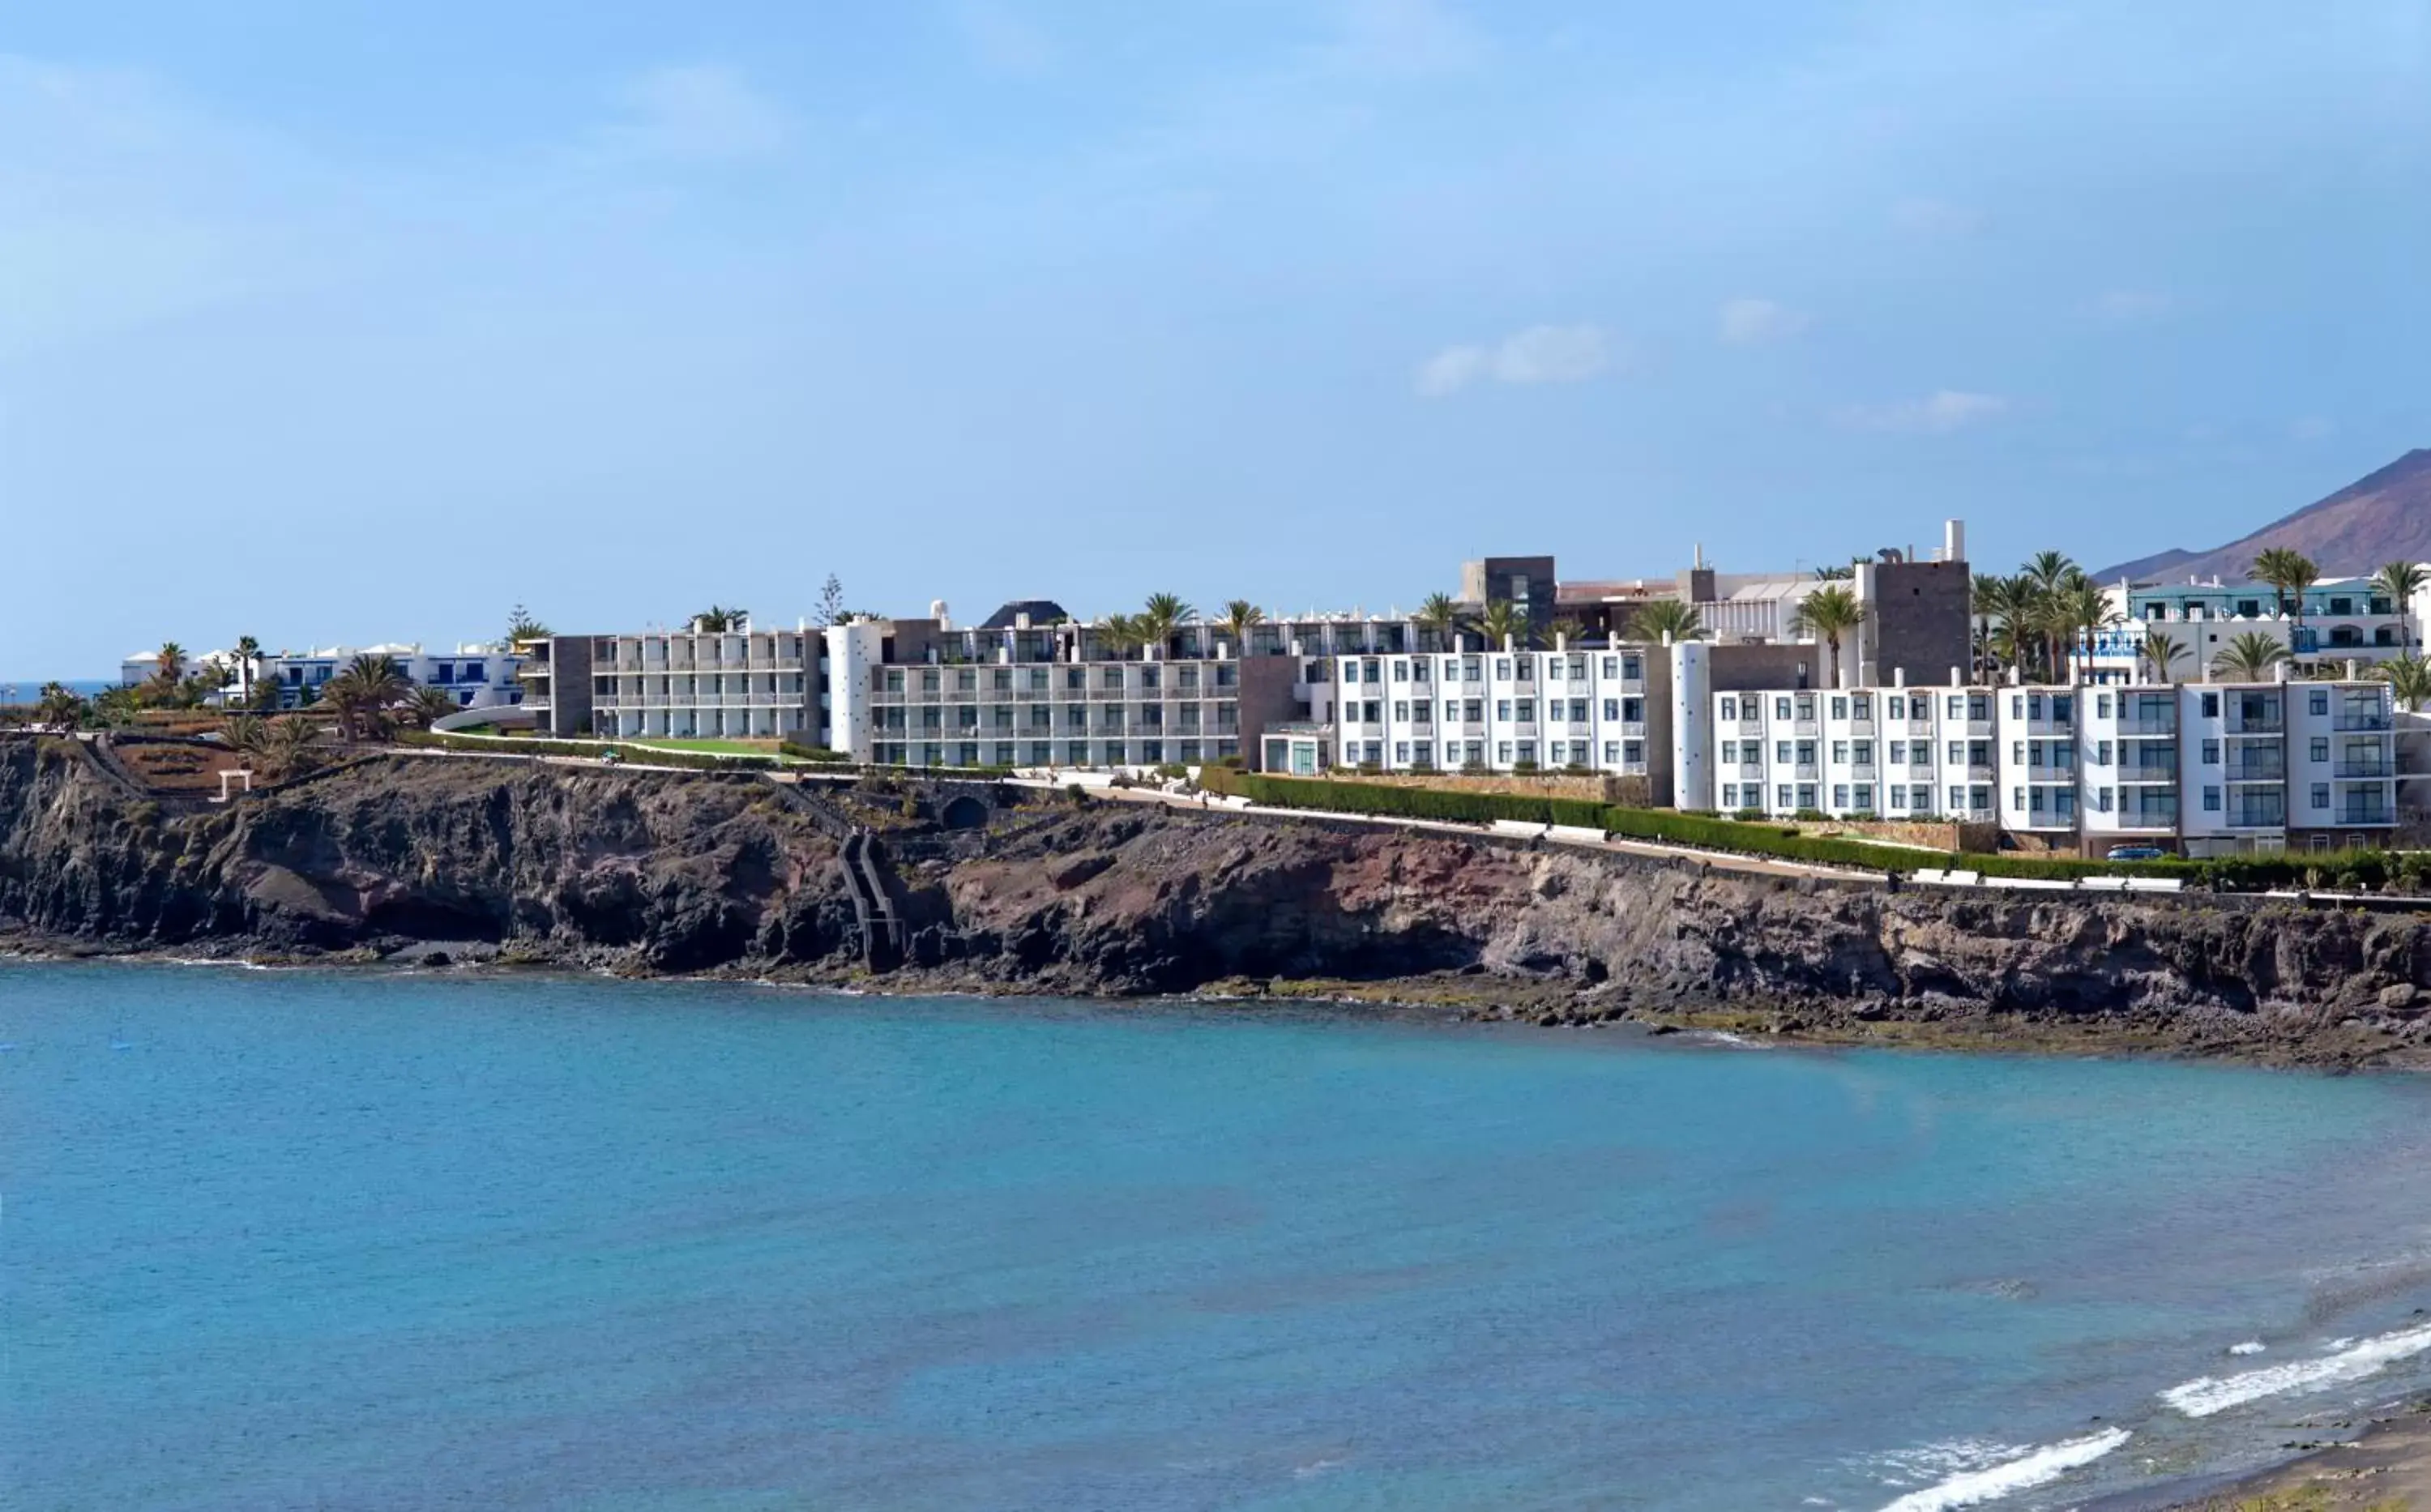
1313 644 1668 778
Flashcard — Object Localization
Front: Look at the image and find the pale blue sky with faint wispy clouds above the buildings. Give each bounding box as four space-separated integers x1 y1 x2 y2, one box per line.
0 0 2431 678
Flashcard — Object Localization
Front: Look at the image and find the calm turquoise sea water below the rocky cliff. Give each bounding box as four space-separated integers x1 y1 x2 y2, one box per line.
0 965 2431 1512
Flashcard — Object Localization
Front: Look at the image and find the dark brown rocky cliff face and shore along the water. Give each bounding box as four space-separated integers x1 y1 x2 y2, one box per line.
0 739 2431 1065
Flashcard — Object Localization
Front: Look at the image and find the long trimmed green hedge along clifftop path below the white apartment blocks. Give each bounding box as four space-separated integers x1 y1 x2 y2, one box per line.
1198 768 2392 892
